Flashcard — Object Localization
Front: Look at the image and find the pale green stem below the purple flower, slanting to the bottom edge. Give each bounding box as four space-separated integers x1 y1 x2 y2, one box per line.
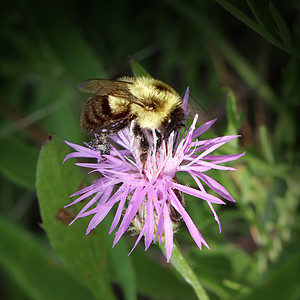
160 239 209 300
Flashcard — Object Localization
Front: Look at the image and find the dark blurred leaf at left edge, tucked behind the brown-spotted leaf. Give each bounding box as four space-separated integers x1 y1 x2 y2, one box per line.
0 137 38 190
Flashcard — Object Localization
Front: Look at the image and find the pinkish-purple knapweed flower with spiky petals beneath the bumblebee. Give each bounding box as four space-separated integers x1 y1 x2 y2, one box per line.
65 89 243 262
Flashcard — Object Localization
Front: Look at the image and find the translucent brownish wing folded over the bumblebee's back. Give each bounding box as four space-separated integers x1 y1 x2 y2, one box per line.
77 78 146 109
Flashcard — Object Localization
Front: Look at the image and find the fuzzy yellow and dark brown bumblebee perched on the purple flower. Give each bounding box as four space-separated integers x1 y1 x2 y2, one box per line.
78 77 184 154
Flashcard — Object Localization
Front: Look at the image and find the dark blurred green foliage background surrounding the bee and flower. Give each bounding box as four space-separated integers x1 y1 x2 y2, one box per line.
0 0 300 299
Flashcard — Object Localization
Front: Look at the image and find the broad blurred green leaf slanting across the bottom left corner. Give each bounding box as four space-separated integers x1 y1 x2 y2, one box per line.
0 217 94 300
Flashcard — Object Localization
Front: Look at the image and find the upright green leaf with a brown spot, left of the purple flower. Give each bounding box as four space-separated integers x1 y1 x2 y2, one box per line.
37 137 114 299
